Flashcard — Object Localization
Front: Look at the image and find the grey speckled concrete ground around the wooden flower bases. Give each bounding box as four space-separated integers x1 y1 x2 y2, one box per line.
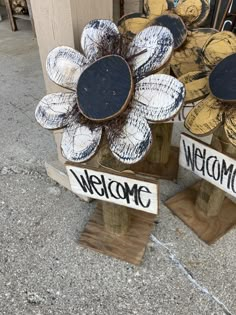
0 8 236 315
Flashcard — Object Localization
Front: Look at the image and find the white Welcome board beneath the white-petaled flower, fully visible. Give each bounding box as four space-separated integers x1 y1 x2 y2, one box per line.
66 164 159 214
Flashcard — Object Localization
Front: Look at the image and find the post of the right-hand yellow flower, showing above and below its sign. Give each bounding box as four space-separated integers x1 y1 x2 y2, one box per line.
196 127 236 217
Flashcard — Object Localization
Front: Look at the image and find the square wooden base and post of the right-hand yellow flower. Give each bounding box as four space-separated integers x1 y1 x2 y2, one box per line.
165 127 236 244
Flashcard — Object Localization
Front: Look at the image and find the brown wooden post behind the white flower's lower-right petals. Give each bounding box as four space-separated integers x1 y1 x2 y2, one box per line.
147 123 173 164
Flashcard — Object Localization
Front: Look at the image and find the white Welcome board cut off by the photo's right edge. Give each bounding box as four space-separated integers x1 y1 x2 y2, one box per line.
179 134 236 197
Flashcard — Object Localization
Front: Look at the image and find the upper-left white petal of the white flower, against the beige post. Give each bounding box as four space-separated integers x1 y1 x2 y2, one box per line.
46 46 89 91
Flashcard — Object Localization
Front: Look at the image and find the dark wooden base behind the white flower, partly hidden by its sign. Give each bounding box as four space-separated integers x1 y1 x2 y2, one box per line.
130 146 179 180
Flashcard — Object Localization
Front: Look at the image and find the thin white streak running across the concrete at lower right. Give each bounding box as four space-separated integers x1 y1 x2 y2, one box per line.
150 235 233 315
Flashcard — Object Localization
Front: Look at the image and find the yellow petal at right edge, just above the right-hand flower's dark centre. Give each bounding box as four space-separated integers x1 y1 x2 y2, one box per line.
202 31 236 67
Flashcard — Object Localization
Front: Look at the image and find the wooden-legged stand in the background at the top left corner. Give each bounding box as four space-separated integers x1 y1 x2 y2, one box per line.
4 0 35 34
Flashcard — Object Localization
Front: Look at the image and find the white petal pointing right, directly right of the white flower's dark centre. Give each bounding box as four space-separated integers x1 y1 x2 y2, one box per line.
131 74 185 122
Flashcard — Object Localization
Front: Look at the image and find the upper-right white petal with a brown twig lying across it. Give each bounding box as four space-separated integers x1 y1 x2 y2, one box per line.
126 25 174 81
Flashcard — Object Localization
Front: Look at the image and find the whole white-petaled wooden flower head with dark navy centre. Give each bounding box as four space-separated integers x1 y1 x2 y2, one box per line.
35 20 185 164
